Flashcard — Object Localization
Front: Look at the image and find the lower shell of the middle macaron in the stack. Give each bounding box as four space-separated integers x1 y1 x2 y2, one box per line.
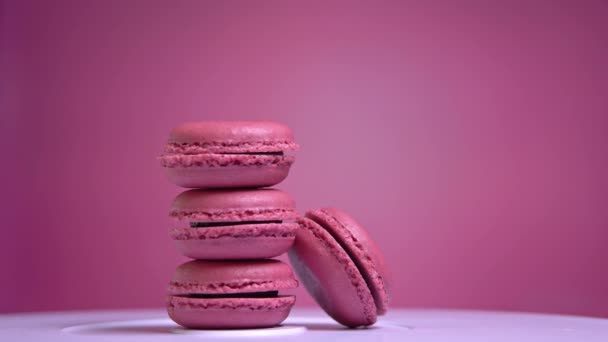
169 223 298 260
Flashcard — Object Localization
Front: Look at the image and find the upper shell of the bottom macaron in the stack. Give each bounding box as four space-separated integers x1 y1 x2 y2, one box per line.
168 259 298 295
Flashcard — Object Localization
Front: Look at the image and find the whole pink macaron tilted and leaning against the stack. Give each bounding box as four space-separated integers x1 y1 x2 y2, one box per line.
289 208 389 327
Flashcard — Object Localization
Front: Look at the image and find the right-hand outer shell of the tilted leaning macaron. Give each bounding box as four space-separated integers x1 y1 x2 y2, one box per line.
306 208 389 315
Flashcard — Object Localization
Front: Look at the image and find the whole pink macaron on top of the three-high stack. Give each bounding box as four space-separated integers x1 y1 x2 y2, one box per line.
159 121 298 188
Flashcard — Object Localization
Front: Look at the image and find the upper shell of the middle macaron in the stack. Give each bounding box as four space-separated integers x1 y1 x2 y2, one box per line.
169 189 298 222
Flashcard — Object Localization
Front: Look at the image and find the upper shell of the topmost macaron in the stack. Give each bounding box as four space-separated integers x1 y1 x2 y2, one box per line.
165 121 298 154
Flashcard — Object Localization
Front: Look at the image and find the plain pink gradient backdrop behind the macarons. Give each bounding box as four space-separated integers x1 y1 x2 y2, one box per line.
0 0 608 316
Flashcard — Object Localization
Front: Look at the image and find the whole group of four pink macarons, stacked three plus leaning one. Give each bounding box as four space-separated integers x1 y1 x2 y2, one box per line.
160 122 389 329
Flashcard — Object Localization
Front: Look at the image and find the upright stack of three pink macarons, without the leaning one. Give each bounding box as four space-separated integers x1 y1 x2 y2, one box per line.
159 122 299 329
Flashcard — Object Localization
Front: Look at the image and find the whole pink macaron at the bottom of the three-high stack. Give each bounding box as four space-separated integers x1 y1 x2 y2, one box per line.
167 260 298 329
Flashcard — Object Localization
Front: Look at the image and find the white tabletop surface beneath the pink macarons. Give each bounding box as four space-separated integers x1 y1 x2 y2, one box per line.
0 309 608 342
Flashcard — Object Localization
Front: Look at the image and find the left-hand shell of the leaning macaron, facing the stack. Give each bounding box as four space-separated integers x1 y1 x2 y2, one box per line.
288 218 377 327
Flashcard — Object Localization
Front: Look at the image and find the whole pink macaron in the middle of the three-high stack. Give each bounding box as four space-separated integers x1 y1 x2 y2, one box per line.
169 189 299 260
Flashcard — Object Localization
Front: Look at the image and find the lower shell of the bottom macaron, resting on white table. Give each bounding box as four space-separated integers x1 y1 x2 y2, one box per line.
167 296 295 329
